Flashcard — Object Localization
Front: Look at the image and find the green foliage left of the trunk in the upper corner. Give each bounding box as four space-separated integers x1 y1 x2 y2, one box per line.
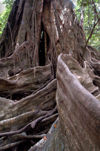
0 0 14 35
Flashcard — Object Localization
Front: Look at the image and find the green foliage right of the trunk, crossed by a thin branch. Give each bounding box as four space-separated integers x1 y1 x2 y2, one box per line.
75 0 100 50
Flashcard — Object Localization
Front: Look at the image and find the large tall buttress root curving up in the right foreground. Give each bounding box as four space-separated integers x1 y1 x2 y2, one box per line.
29 54 100 151
